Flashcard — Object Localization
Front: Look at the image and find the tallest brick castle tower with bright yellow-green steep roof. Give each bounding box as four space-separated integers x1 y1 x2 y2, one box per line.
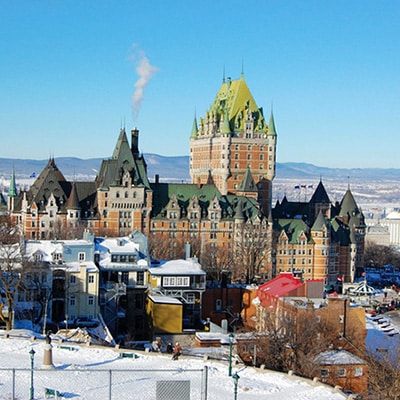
190 74 277 215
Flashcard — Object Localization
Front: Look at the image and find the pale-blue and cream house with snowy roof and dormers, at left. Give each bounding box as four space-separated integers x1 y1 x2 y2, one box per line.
23 234 100 323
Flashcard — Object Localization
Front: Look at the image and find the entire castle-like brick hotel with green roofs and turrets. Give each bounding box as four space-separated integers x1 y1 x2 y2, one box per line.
8 74 365 284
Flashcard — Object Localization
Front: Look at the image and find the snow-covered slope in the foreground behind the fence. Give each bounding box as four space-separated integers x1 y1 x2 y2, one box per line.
0 330 346 400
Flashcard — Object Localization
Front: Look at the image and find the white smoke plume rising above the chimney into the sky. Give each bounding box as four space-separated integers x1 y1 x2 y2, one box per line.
132 50 158 118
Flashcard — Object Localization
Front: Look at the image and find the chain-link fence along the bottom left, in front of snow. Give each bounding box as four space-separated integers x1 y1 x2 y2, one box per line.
0 366 208 400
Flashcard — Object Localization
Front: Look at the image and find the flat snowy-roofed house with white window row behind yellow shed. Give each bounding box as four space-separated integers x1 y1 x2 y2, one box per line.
149 258 206 333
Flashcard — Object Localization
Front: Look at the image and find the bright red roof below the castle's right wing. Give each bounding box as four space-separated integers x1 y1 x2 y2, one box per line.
257 272 304 305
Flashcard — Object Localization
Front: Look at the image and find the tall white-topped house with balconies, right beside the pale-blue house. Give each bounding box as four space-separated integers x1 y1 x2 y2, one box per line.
95 230 150 340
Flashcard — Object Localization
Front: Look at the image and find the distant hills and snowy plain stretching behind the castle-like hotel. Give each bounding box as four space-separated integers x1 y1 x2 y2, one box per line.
0 153 400 207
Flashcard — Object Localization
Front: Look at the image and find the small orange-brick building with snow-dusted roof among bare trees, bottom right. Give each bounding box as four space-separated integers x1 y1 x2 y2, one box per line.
315 350 368 395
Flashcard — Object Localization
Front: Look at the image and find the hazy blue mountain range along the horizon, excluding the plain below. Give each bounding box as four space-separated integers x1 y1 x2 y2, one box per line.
0 153 400 182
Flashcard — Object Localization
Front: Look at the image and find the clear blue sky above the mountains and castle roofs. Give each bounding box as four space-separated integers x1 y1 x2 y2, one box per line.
0 0 400 168
